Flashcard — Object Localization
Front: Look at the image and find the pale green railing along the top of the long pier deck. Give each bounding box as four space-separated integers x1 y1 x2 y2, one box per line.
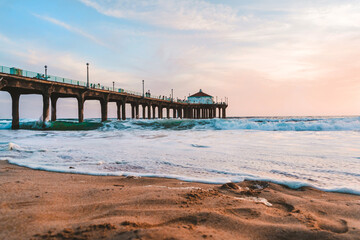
0 65 225 104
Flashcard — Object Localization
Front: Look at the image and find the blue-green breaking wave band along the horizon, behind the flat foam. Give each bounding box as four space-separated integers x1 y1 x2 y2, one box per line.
0 117 360 131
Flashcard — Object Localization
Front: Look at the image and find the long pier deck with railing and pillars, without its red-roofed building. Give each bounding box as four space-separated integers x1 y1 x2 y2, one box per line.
0 66 228 129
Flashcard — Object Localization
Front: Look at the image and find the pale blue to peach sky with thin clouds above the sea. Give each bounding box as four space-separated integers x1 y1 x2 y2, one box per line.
0 0 360 118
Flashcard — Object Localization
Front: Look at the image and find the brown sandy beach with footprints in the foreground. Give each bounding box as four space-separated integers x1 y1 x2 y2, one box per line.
0 161 360 239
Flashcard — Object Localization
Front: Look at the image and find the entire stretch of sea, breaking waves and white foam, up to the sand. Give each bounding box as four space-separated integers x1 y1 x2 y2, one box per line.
0 117 360 194
